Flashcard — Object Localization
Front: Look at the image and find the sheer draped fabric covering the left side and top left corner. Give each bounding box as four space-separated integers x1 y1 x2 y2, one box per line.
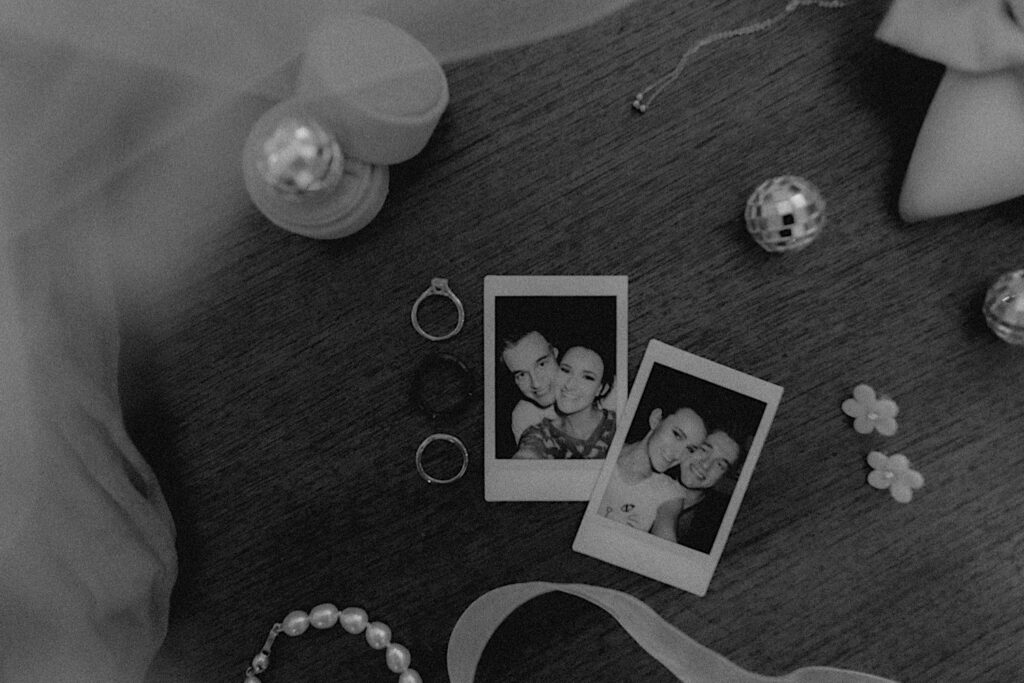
0 0 626 683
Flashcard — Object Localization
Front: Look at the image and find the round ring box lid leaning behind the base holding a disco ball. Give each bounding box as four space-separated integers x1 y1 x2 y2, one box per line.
296 12 449 164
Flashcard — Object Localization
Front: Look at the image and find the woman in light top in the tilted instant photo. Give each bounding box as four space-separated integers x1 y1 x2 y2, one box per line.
598 407 708 540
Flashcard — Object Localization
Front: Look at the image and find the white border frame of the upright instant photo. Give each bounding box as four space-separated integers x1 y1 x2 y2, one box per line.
483 275 629 502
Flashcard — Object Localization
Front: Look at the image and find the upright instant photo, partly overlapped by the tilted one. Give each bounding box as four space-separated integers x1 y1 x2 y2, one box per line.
483 275 629 501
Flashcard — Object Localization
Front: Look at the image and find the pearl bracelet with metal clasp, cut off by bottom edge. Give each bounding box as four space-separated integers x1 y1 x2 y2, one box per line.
245 602 423 683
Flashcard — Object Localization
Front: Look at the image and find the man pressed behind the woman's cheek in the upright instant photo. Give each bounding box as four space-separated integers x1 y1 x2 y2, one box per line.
501 328 558 443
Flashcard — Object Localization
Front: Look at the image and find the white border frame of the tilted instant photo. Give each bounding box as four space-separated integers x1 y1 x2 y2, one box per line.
572 340 782 596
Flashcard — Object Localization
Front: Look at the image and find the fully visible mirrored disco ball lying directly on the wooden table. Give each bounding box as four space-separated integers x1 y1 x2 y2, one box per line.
744 175 825 253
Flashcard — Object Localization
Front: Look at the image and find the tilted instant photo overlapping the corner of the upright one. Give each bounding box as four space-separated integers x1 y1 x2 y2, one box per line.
572 340 782 596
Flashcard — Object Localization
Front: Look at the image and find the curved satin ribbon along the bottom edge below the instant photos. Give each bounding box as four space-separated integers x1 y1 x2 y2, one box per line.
447 582 893 683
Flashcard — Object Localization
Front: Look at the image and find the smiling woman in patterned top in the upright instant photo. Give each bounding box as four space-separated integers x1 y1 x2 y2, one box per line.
513 344 615 460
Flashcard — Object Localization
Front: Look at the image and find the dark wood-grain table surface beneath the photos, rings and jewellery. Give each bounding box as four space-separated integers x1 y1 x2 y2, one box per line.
126 0 1024 683
